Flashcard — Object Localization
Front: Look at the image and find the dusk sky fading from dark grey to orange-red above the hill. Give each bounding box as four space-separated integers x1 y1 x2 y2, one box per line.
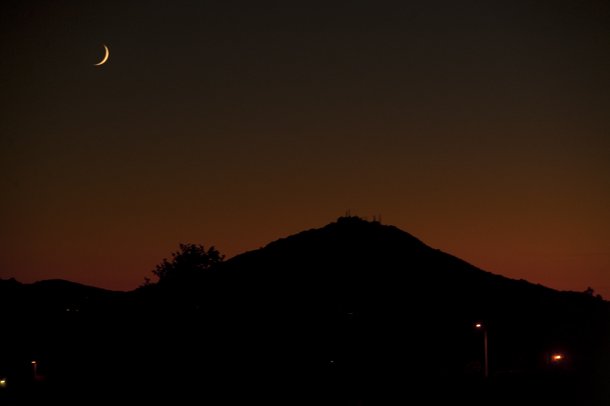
0 0 610 299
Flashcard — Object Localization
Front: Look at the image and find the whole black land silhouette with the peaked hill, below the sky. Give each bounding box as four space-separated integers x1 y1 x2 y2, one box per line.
0 217 610 404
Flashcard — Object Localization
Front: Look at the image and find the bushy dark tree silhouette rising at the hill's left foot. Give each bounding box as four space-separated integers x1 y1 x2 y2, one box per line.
145 244 224 285
